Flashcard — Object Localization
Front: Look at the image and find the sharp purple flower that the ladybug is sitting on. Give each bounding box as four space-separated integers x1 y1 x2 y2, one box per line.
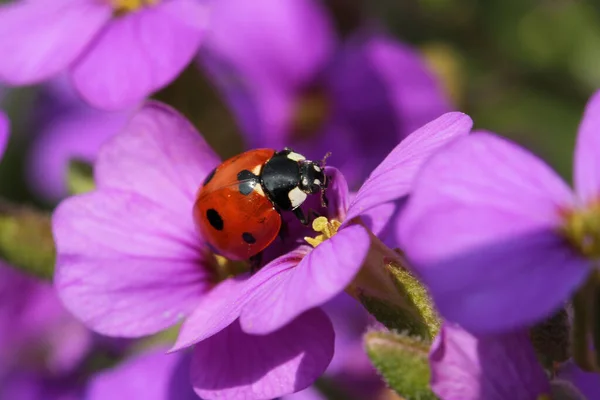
53 99 470 399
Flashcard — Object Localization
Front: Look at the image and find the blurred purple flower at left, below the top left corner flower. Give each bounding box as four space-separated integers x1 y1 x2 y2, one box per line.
27 76 134 202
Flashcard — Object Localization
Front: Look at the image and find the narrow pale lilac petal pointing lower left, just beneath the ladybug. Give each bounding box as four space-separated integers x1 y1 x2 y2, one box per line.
171 250 304 351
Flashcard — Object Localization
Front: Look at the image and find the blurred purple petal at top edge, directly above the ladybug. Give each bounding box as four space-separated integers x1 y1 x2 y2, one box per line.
200 0 335 148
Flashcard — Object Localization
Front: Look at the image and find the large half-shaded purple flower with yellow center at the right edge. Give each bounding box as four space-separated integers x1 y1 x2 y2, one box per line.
399 93 600 333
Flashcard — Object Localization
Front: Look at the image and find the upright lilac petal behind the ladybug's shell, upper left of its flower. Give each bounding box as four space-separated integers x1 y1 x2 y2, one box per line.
95 102 220 217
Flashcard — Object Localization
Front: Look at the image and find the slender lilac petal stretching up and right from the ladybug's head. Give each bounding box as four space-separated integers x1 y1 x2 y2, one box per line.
346 112 472 227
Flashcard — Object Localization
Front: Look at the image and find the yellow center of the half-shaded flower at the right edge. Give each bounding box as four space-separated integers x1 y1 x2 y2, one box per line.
561 202 600 259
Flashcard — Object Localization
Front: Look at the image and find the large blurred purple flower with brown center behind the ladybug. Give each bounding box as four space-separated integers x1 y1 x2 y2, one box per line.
200 0 450 188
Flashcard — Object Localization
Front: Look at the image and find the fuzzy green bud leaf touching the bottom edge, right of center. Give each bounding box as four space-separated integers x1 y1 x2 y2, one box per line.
364 331 437 400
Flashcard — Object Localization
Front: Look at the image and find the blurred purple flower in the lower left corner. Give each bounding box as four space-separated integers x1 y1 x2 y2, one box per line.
0 265 93 400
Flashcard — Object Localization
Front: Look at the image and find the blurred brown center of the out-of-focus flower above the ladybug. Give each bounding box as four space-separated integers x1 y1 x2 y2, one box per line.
291 88 330 140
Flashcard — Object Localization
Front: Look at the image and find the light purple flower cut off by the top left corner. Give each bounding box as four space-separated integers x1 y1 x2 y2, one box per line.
0 0 208 109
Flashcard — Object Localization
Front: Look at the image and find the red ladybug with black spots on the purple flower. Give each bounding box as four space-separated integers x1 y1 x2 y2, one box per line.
193 148 327 265
